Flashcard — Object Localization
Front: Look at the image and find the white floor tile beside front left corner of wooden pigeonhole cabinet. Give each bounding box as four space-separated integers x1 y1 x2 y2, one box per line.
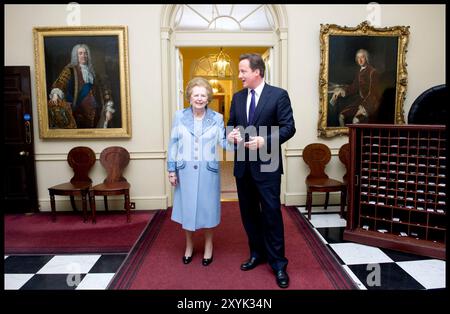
330 243 393 265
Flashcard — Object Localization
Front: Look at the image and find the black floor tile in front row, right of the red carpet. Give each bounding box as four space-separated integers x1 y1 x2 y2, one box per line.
348 263 425 290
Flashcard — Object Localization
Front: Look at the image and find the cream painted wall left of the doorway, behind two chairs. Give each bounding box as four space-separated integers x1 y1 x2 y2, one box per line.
5 5 167 211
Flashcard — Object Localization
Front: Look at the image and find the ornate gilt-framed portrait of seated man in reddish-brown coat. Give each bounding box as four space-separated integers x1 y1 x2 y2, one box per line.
318 21 409 137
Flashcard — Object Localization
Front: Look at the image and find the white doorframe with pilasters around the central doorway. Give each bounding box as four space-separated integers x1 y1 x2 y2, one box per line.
161 4 288 206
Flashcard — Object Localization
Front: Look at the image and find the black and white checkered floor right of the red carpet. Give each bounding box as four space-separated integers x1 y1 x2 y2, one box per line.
298 206 445 290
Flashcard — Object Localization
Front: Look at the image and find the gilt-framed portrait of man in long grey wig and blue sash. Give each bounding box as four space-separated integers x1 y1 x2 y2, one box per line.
33 26 131 139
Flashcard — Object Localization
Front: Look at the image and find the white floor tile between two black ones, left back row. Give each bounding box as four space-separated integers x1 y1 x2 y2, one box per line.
37 254 101 274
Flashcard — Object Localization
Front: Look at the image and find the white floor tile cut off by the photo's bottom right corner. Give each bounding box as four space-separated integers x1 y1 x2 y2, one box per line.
397 259 445 289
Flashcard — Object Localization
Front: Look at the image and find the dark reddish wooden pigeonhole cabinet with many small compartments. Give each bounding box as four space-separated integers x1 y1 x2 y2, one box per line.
344 124 447 259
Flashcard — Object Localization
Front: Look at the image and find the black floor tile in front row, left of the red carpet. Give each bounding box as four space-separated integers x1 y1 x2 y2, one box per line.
20 274 86 290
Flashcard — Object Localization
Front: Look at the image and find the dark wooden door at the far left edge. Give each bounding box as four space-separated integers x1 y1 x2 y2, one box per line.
2 66 38 213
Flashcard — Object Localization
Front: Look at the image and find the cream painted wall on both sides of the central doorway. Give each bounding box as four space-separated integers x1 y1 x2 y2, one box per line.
5 5 446 210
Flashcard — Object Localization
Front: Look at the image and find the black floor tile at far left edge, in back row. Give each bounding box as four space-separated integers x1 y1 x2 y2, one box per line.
4 255 54 274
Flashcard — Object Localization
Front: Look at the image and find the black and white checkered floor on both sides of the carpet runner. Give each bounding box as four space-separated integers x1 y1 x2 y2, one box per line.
4 206 445 290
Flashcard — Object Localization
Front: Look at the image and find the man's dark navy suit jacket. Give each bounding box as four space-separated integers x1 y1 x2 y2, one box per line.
227 84 295 180
